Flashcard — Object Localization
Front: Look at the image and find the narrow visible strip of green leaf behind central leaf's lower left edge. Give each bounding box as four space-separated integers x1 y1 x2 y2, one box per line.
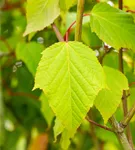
39 93 54 127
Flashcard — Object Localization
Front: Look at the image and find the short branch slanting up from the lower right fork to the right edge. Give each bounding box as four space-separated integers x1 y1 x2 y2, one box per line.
120 104 135 128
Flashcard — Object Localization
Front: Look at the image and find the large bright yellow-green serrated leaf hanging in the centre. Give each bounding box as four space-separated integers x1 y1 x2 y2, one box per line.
35 41 105 131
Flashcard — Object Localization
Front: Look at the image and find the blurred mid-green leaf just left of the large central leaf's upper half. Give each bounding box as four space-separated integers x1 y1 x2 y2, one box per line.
16 42 44 76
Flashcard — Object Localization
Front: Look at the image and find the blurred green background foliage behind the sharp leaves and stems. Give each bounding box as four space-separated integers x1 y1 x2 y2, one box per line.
0 0 135 150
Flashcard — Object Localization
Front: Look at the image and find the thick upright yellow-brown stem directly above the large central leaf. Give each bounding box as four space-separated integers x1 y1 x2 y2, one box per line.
75 0 85 41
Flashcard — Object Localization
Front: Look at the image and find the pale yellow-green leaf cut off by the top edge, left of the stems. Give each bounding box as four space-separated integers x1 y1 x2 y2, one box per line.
24 0 60 36
